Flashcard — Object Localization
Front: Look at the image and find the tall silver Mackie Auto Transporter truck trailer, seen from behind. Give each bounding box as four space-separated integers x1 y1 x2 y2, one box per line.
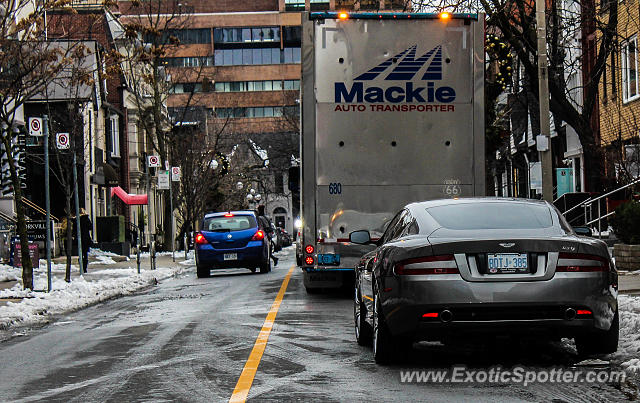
299 12 485 292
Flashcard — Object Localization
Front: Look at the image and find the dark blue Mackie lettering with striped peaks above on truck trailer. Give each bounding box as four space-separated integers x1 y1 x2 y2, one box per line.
335 45 456 103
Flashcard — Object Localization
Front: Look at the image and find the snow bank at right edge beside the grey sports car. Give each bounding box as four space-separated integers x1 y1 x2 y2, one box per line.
615 295 640 372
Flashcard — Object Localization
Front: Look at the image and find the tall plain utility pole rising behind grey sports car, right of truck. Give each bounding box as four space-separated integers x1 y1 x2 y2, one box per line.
536 0 553 203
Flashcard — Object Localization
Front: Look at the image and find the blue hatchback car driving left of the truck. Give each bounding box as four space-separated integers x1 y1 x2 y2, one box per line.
194 211 271 278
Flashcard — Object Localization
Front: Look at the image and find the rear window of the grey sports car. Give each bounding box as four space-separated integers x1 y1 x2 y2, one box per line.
427 202 553 230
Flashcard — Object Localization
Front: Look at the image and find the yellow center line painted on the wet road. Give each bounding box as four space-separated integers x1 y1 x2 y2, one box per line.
229 266 295 403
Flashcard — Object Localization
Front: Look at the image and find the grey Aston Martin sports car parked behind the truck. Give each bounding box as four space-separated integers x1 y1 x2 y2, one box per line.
349 198 619 363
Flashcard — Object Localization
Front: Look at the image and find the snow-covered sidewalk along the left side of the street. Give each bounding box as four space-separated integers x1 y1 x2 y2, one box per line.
0 251 194 330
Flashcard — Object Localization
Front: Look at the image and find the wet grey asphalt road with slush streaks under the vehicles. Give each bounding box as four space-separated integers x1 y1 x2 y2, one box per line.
0 250 630 402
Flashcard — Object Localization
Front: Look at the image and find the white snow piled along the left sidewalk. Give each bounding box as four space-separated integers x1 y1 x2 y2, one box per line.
0 258 187 329
